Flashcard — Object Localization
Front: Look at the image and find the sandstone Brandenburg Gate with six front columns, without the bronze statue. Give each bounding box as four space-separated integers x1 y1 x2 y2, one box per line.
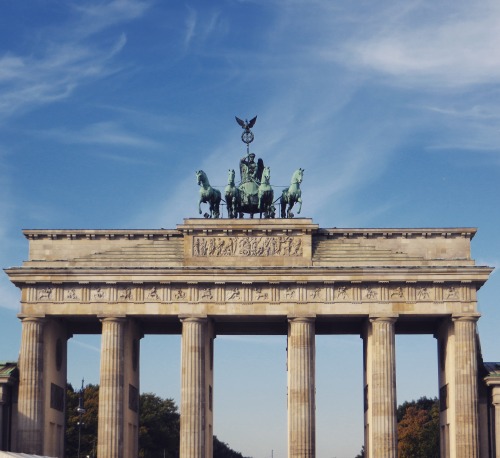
6 218 492 458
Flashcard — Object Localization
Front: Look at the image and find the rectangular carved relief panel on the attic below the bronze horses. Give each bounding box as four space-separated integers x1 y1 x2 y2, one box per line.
193 235 303 257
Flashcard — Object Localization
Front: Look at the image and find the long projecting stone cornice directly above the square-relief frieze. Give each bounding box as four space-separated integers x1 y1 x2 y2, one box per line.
5 266 493 287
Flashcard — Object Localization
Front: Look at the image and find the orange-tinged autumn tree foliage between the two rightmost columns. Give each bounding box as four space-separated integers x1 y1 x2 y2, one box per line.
398 397 439 458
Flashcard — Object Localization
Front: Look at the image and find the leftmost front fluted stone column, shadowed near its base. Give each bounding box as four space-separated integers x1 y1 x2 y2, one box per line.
16 317 44 455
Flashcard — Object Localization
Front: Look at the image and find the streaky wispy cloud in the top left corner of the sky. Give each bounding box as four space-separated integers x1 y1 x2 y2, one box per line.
0 0 147 118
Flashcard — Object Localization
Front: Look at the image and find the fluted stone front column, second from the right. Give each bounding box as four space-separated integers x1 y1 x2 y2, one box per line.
365 316 398 458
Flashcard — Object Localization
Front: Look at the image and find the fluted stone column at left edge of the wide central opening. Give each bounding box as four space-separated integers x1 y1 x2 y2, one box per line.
180 317 209 458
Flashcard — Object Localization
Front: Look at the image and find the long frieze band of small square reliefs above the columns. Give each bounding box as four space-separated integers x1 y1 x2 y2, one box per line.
29 281 472 303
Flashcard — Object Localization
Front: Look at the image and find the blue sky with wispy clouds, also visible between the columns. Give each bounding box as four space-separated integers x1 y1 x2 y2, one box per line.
0 0 500 458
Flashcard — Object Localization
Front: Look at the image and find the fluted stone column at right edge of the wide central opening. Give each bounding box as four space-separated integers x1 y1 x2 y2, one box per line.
288 317 316 458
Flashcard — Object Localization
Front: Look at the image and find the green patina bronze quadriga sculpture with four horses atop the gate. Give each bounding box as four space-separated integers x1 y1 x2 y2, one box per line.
196 116 304 218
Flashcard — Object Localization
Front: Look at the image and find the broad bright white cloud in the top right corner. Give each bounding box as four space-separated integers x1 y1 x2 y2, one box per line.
334 1 500 88
